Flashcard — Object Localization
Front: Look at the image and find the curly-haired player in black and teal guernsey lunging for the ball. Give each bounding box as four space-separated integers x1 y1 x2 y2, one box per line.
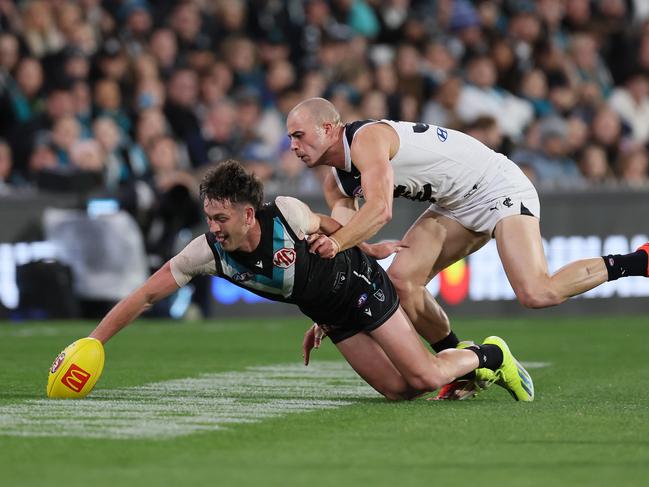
90 161 534 401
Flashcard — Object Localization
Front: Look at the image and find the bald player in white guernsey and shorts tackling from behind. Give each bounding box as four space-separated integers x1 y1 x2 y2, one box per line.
286 98 649 397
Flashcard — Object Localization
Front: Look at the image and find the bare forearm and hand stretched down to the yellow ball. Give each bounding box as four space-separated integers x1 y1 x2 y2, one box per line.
90 262 178 343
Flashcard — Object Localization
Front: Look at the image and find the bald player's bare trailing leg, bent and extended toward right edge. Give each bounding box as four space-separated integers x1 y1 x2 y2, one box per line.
495 215 608 308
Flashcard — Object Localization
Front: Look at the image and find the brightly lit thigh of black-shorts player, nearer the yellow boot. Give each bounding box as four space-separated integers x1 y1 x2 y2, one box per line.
371 308 435 385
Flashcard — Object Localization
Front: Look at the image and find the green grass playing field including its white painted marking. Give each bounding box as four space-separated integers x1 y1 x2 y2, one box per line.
0 317 649 487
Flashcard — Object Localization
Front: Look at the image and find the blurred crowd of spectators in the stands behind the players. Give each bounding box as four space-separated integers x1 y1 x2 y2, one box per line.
0 0 649 266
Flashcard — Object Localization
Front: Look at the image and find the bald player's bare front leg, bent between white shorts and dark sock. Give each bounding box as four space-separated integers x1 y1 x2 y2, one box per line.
388 210 489 344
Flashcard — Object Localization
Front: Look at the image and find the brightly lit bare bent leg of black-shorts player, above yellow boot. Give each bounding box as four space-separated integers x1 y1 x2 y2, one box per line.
370 308 479 392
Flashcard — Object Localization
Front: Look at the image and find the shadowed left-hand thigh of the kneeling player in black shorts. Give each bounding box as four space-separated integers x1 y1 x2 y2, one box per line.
336 332 409 399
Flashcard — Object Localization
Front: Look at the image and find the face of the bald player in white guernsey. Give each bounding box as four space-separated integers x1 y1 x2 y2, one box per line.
286 110 329 167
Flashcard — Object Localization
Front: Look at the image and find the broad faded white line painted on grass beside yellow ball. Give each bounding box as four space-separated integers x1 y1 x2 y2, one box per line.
0 362 378 439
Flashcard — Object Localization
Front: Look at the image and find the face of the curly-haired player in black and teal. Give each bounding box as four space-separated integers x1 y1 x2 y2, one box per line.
203 198 254 252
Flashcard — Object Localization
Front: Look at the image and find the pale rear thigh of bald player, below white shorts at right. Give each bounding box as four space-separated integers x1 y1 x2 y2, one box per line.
494 215 549 290
